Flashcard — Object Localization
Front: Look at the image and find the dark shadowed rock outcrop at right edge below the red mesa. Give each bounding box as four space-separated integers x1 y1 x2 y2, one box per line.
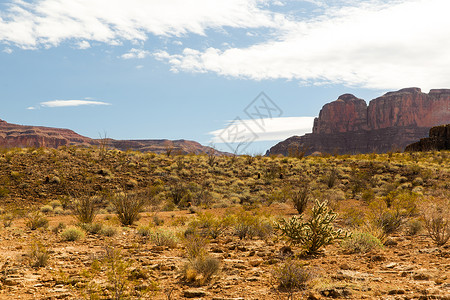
405 124 450 152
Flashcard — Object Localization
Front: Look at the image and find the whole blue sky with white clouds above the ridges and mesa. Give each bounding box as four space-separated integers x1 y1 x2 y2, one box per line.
0 0 450 154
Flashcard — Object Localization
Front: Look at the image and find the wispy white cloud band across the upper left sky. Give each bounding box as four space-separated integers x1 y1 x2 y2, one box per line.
0 0 281 49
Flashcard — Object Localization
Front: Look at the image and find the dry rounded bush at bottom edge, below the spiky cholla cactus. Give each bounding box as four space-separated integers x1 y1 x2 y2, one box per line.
272 259 312 299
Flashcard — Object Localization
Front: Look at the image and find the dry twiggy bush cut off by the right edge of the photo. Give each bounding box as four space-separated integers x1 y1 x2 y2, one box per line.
423 204 450 246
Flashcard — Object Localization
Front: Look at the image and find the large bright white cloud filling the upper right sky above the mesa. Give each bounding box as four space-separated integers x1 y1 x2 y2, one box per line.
155 0 450 89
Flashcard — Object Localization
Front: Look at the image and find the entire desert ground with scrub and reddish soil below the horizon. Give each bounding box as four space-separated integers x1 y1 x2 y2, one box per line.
0 147 450 299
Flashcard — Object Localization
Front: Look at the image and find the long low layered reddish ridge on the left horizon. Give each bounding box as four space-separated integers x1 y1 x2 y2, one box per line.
0 120 225 154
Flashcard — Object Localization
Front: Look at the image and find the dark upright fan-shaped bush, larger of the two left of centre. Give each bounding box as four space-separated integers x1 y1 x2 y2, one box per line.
112 193 148 226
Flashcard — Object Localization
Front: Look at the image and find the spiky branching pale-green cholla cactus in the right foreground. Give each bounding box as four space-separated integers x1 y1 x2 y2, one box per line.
275 200 348 254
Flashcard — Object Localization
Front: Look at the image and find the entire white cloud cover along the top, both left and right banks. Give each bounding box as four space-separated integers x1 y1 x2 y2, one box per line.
0 0 450 90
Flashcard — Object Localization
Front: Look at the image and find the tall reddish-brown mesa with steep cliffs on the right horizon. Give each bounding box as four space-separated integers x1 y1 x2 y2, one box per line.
268 88 450 155
